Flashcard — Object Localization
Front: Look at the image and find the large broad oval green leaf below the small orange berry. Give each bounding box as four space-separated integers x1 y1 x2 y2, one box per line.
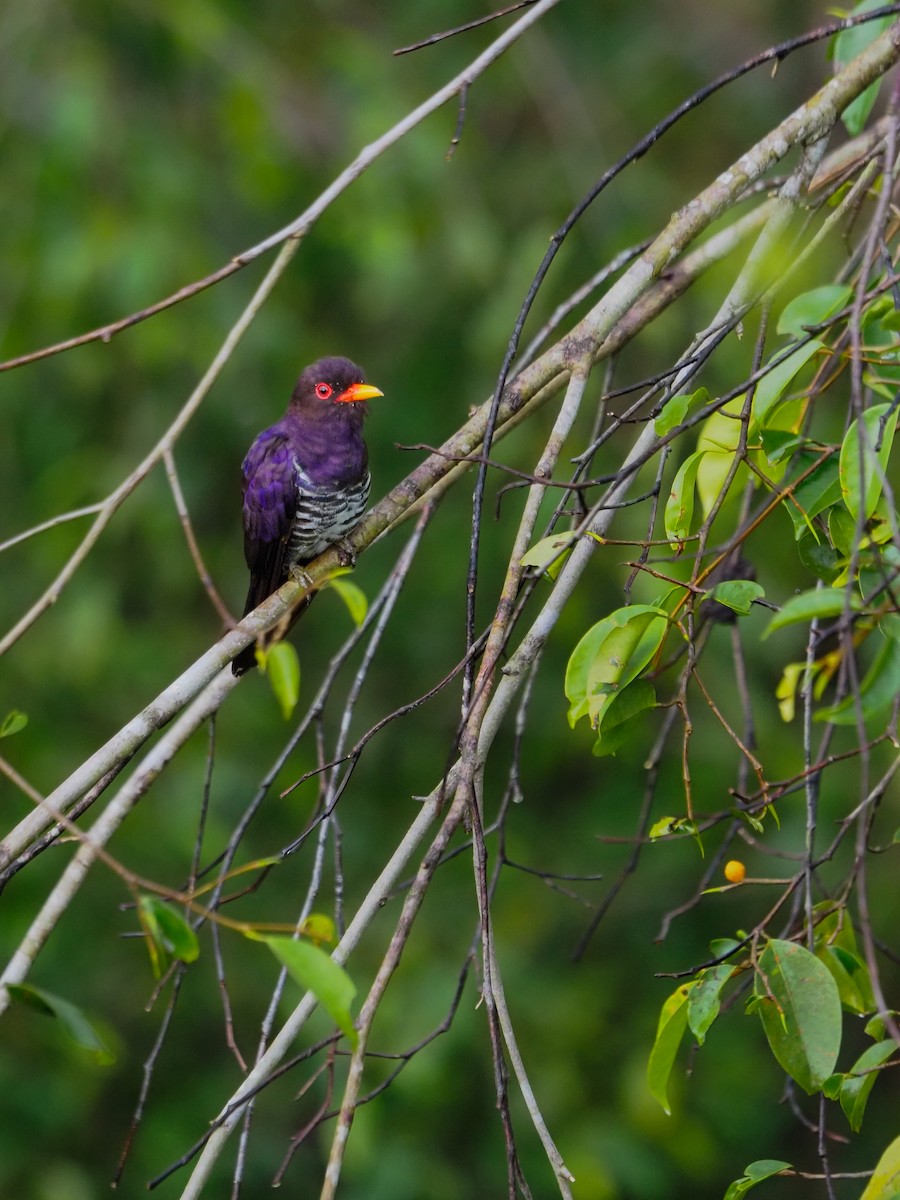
755 938 841 1096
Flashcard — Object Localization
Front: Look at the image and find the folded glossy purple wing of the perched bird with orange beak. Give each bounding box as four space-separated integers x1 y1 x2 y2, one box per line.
242 426 296 616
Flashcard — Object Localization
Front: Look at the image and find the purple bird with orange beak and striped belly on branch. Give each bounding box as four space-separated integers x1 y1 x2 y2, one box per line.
232 356 384 676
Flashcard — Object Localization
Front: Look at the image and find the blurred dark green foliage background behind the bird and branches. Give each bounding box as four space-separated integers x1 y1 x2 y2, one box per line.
0 0 898 1200
